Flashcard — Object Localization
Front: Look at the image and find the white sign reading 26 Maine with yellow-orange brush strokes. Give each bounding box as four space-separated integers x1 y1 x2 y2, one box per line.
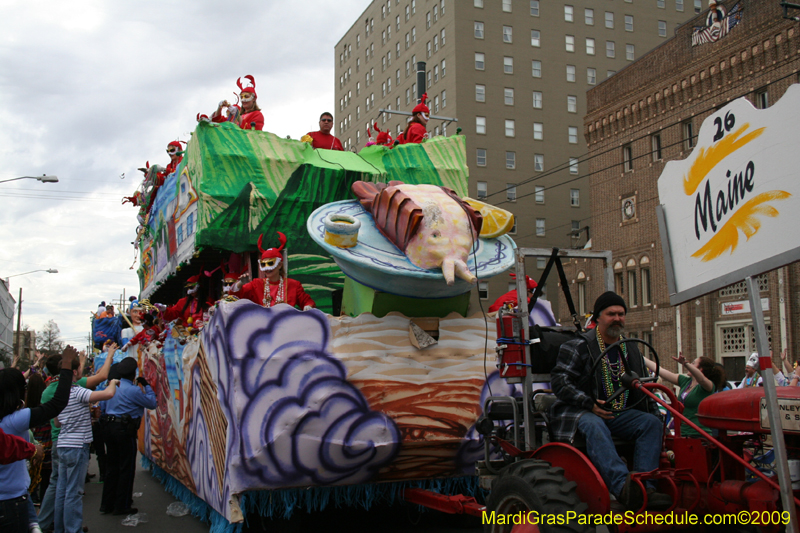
658 84 800 305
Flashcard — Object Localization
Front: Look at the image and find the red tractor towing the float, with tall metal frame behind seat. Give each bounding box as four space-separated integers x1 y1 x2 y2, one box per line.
405 250 800 533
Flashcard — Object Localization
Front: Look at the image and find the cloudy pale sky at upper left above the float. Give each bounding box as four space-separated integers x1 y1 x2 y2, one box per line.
0 0 370 346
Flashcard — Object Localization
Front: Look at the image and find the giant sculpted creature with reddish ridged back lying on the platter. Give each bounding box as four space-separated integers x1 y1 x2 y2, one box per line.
352 181 483 285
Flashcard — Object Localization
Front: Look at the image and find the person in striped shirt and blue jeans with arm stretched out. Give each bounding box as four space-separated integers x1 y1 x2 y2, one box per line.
54 354 119 533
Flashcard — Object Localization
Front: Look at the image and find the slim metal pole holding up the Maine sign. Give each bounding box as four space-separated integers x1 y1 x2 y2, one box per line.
745 276 798 533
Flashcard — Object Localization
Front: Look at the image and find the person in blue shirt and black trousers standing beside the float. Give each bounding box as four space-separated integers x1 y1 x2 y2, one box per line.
100 357 156 515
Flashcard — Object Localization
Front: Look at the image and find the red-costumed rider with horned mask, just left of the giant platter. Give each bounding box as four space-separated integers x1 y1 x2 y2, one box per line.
233 231 317 311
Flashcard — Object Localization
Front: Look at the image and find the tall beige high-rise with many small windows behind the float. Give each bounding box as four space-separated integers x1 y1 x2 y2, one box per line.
335 0 700 312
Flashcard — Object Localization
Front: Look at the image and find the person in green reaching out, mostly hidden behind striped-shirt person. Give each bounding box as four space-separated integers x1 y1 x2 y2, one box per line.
39 344 117 531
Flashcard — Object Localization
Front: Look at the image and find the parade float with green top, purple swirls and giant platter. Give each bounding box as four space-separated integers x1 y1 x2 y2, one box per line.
128 122 528 531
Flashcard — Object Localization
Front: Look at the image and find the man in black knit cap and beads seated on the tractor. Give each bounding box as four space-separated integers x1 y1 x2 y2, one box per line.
550 291 672 510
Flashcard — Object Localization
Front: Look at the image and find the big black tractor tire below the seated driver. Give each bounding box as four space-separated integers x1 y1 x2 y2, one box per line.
483 459 591 533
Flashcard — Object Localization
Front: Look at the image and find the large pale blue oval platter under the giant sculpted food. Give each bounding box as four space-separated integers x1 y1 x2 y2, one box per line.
306 200 516 298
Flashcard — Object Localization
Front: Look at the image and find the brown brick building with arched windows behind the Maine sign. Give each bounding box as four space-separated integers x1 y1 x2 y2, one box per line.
561 0 800 380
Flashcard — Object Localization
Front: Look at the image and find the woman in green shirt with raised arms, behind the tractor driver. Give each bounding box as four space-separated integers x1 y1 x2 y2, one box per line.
644 353 722 437
